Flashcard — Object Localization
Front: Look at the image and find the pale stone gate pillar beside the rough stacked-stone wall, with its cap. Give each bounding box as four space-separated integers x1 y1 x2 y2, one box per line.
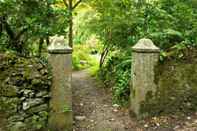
48 37 73 131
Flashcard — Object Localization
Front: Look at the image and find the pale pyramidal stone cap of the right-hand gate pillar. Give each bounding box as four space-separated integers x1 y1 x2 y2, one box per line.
132 38 160 53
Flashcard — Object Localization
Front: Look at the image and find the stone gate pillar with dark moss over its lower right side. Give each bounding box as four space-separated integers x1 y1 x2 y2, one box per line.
130 39 160 119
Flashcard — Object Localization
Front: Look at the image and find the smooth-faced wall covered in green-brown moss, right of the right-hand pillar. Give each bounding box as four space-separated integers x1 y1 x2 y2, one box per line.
141 51 197 116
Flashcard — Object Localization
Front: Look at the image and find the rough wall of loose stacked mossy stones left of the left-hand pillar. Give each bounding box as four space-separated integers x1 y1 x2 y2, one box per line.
0 55 51 131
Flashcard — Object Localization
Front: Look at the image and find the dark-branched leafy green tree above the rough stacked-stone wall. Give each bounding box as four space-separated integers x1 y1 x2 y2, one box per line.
0 0 68 55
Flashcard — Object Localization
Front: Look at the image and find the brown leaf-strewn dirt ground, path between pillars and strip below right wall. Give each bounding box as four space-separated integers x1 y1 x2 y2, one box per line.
72 70 197 131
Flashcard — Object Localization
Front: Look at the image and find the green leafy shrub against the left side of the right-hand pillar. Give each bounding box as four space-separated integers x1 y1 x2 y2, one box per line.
99 51 131 105
